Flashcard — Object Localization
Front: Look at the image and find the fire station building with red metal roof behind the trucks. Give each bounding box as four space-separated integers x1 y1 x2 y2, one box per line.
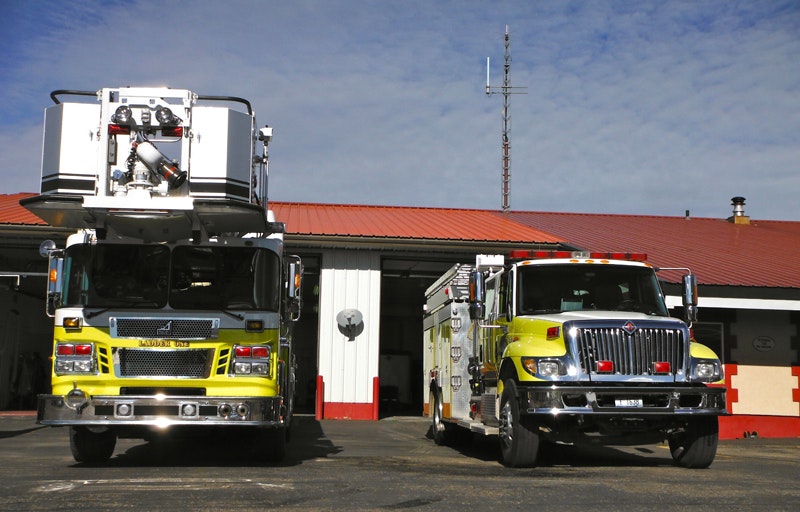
0 194 800 438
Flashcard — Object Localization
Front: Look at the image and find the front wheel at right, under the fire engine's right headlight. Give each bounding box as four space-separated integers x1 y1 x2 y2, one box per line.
669 416 719 468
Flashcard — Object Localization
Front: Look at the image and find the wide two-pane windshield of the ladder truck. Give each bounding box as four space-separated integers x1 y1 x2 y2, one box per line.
61 244 280 311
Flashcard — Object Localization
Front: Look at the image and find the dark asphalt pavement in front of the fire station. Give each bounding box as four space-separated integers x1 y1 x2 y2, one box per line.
0 413 800 512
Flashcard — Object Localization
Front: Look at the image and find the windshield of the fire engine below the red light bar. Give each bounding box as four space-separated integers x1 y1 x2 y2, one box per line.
517 264 668 316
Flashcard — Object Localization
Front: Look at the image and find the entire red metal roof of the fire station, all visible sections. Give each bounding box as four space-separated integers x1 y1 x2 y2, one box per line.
0 193 800 289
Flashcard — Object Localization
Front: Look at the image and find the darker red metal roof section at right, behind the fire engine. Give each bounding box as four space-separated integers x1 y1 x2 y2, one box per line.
510 212 800 288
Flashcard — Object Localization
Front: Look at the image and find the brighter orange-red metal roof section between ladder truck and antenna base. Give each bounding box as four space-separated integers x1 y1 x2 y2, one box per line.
269 201 564 243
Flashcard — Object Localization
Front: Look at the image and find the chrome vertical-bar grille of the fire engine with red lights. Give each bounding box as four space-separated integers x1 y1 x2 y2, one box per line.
578 328 684 375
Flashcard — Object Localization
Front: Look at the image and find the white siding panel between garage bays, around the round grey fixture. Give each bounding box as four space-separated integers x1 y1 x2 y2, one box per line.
319 250 381 403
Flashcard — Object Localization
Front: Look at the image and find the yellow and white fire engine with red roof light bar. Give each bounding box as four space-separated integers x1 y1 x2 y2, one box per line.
423 251 726 468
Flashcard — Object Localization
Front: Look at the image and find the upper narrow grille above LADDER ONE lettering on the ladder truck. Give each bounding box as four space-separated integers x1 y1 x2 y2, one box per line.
111 318 219 340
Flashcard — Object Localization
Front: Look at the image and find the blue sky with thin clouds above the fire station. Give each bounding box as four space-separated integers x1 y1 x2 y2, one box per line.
0 0 800 221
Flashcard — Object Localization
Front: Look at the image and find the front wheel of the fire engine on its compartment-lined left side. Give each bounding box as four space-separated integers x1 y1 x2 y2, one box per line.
500 379 539 468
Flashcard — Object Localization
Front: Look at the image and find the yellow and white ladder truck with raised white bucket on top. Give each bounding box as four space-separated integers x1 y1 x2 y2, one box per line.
20 87 302 463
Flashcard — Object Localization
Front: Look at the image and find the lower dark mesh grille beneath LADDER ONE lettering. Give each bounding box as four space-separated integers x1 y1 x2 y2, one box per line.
119 348 213 379
